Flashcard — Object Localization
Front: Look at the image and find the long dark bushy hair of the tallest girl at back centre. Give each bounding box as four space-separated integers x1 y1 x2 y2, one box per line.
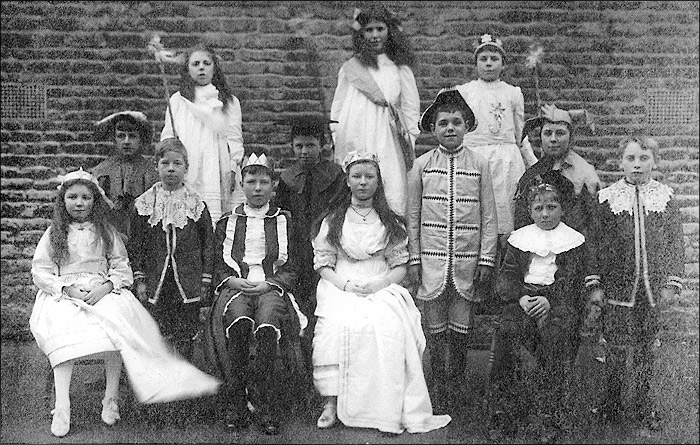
352 5 416 68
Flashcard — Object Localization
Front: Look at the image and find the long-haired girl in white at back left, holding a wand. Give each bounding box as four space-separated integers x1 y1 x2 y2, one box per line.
160 46 244 224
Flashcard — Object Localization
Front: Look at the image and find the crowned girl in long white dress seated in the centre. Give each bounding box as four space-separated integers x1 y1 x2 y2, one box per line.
313 153 451 434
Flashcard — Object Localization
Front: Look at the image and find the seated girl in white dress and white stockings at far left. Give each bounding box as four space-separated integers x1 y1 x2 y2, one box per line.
29 169 219 437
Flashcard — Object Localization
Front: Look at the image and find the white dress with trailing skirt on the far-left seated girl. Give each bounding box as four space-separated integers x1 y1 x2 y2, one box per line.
29 222 220 403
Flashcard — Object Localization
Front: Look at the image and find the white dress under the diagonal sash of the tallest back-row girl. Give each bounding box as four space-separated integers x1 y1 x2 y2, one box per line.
331 54 420 215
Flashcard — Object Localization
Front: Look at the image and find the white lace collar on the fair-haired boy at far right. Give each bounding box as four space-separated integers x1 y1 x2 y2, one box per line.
598 179 673 215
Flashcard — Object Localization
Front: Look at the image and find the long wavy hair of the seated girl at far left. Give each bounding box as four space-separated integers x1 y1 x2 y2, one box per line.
49 179 116 267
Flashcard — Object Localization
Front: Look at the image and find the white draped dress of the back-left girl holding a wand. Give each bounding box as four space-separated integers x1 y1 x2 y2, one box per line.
160 84 244 225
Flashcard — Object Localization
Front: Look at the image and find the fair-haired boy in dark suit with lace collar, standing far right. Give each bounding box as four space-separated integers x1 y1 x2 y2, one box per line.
586 136 685 430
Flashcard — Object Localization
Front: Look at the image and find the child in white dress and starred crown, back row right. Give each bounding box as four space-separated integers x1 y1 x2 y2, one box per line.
457 34 537 257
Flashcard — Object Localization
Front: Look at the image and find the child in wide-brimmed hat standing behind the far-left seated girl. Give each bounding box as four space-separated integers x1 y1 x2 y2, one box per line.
91 111 159 239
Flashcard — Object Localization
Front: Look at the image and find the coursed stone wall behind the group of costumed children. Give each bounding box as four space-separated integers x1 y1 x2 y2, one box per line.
0 1 699 336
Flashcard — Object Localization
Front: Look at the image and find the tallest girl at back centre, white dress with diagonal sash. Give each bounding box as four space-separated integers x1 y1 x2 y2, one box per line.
331 5 420 215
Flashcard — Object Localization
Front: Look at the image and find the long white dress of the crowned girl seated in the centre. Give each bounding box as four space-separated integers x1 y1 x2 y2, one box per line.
313 214 451 434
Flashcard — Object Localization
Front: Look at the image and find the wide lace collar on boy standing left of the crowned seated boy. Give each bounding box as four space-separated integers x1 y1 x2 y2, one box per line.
134 182 205 231
